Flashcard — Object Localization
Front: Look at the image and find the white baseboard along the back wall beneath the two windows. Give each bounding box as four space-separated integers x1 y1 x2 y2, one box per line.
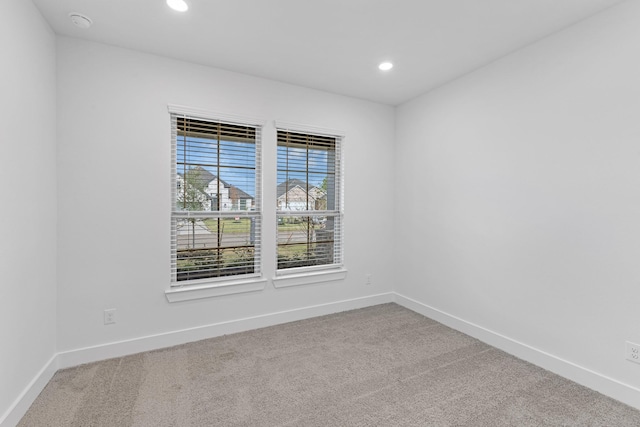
58 292 394 369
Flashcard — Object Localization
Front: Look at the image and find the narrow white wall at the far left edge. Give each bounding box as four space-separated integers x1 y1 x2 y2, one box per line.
0 0 57 422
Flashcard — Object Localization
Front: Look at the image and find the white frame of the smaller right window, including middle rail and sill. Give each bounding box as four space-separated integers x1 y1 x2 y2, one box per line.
273 121 347 280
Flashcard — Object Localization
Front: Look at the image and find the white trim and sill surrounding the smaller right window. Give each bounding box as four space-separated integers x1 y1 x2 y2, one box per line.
272 120 348 280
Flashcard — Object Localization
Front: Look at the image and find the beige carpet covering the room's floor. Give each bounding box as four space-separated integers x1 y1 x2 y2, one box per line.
19 304 640 427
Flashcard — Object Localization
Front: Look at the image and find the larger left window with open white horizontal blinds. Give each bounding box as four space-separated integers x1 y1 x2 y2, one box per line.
171 111 262 286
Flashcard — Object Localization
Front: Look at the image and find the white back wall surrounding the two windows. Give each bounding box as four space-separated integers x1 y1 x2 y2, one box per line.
57 37 394 352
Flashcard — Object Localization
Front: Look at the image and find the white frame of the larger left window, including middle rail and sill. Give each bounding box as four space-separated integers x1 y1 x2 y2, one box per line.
165 105 266 294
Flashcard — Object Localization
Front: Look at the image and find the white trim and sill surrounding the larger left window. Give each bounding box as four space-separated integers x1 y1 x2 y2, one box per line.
165 104 267 296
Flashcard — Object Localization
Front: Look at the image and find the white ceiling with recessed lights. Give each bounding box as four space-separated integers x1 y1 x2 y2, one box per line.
33 0 621 105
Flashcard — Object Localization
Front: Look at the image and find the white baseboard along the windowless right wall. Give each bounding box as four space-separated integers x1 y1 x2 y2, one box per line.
394 293 640 409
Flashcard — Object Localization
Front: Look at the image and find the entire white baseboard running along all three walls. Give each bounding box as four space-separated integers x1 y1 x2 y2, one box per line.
0 292 640 427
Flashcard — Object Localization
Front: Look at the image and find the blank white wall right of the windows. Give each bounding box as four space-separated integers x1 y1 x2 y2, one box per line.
395 1 640 405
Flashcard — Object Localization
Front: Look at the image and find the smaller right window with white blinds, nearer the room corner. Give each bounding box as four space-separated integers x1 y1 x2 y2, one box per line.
276 125 342 273
